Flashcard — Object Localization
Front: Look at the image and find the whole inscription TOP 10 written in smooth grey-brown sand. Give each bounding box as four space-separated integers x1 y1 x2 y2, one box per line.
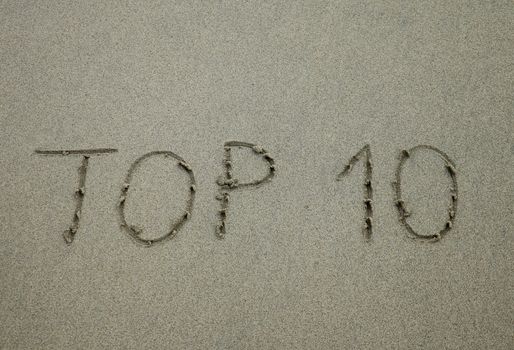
35 141 458 247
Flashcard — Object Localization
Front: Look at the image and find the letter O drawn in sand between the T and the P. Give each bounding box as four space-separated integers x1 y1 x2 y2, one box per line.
118 151 196 247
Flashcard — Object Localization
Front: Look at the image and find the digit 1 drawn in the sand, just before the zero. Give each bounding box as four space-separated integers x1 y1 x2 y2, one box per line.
336 144 373 240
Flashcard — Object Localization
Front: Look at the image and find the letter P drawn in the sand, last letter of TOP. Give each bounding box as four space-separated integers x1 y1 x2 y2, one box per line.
216 141 276 239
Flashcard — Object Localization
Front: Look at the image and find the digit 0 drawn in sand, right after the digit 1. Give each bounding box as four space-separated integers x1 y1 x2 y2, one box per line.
393 145 458 242
